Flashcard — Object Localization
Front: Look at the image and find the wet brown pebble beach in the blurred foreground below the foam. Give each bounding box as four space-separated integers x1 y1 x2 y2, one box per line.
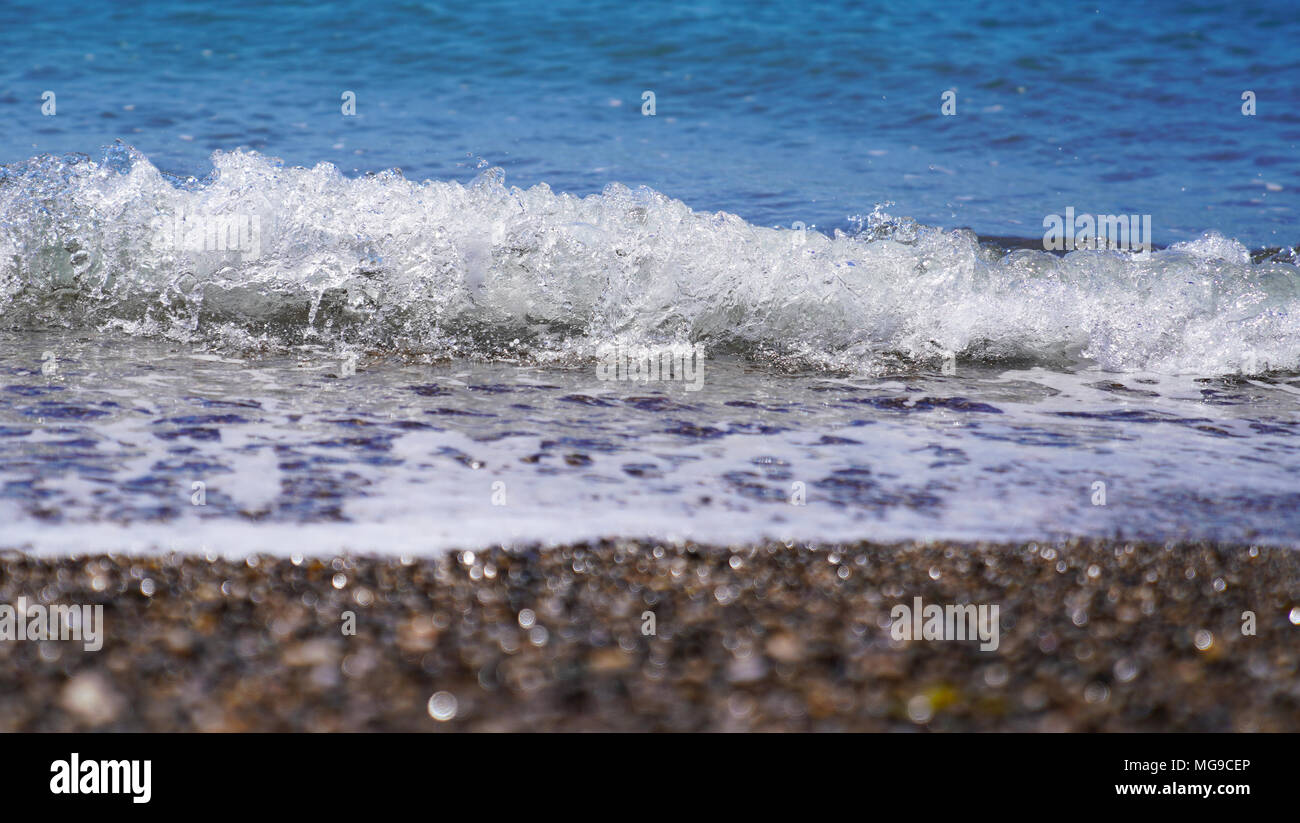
0 541 1300 732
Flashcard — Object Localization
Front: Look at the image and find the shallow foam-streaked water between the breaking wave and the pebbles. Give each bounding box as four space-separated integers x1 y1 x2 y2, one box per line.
0 332 1300 554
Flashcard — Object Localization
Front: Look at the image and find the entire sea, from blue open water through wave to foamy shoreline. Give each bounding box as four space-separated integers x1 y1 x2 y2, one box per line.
0 3 1300 553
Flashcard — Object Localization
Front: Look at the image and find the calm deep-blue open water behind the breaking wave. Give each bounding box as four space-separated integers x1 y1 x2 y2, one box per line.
0 0 1300 247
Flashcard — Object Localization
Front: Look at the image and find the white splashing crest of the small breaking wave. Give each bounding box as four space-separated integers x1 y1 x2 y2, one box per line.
0 144 1300 374
